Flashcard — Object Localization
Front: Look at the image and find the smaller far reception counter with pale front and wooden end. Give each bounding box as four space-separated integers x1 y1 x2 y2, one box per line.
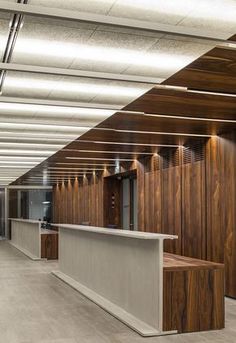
9 218 58 261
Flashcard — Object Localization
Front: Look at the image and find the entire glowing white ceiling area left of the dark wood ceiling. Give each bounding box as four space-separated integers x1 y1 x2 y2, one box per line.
0 0 236 185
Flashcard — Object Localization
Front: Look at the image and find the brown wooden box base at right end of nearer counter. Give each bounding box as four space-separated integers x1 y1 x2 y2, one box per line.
163 254 225 333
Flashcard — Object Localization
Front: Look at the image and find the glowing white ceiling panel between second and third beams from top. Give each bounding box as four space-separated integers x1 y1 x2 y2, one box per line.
2 72 150 106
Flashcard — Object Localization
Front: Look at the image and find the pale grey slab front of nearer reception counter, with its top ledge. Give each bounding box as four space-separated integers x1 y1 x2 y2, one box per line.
51 224 177 336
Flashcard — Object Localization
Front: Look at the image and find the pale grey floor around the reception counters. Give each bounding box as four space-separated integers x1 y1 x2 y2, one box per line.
0 241 236 343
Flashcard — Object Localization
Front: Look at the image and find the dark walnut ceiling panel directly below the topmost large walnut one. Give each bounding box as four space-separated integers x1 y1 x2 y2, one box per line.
125 88 236 120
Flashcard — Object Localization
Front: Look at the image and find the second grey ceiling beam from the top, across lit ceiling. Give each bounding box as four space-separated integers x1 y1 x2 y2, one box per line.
0 63 165 85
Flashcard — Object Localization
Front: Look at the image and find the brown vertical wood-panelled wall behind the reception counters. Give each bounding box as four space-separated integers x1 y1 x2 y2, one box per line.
54 132 236 297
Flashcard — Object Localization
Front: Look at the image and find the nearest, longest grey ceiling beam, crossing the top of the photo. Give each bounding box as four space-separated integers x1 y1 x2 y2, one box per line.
0 0 232 42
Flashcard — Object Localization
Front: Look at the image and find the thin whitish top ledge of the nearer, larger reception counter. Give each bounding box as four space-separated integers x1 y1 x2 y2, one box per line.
51 224 178 240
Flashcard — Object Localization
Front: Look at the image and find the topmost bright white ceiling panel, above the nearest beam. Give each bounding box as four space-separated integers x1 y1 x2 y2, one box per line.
30 0 236 38
